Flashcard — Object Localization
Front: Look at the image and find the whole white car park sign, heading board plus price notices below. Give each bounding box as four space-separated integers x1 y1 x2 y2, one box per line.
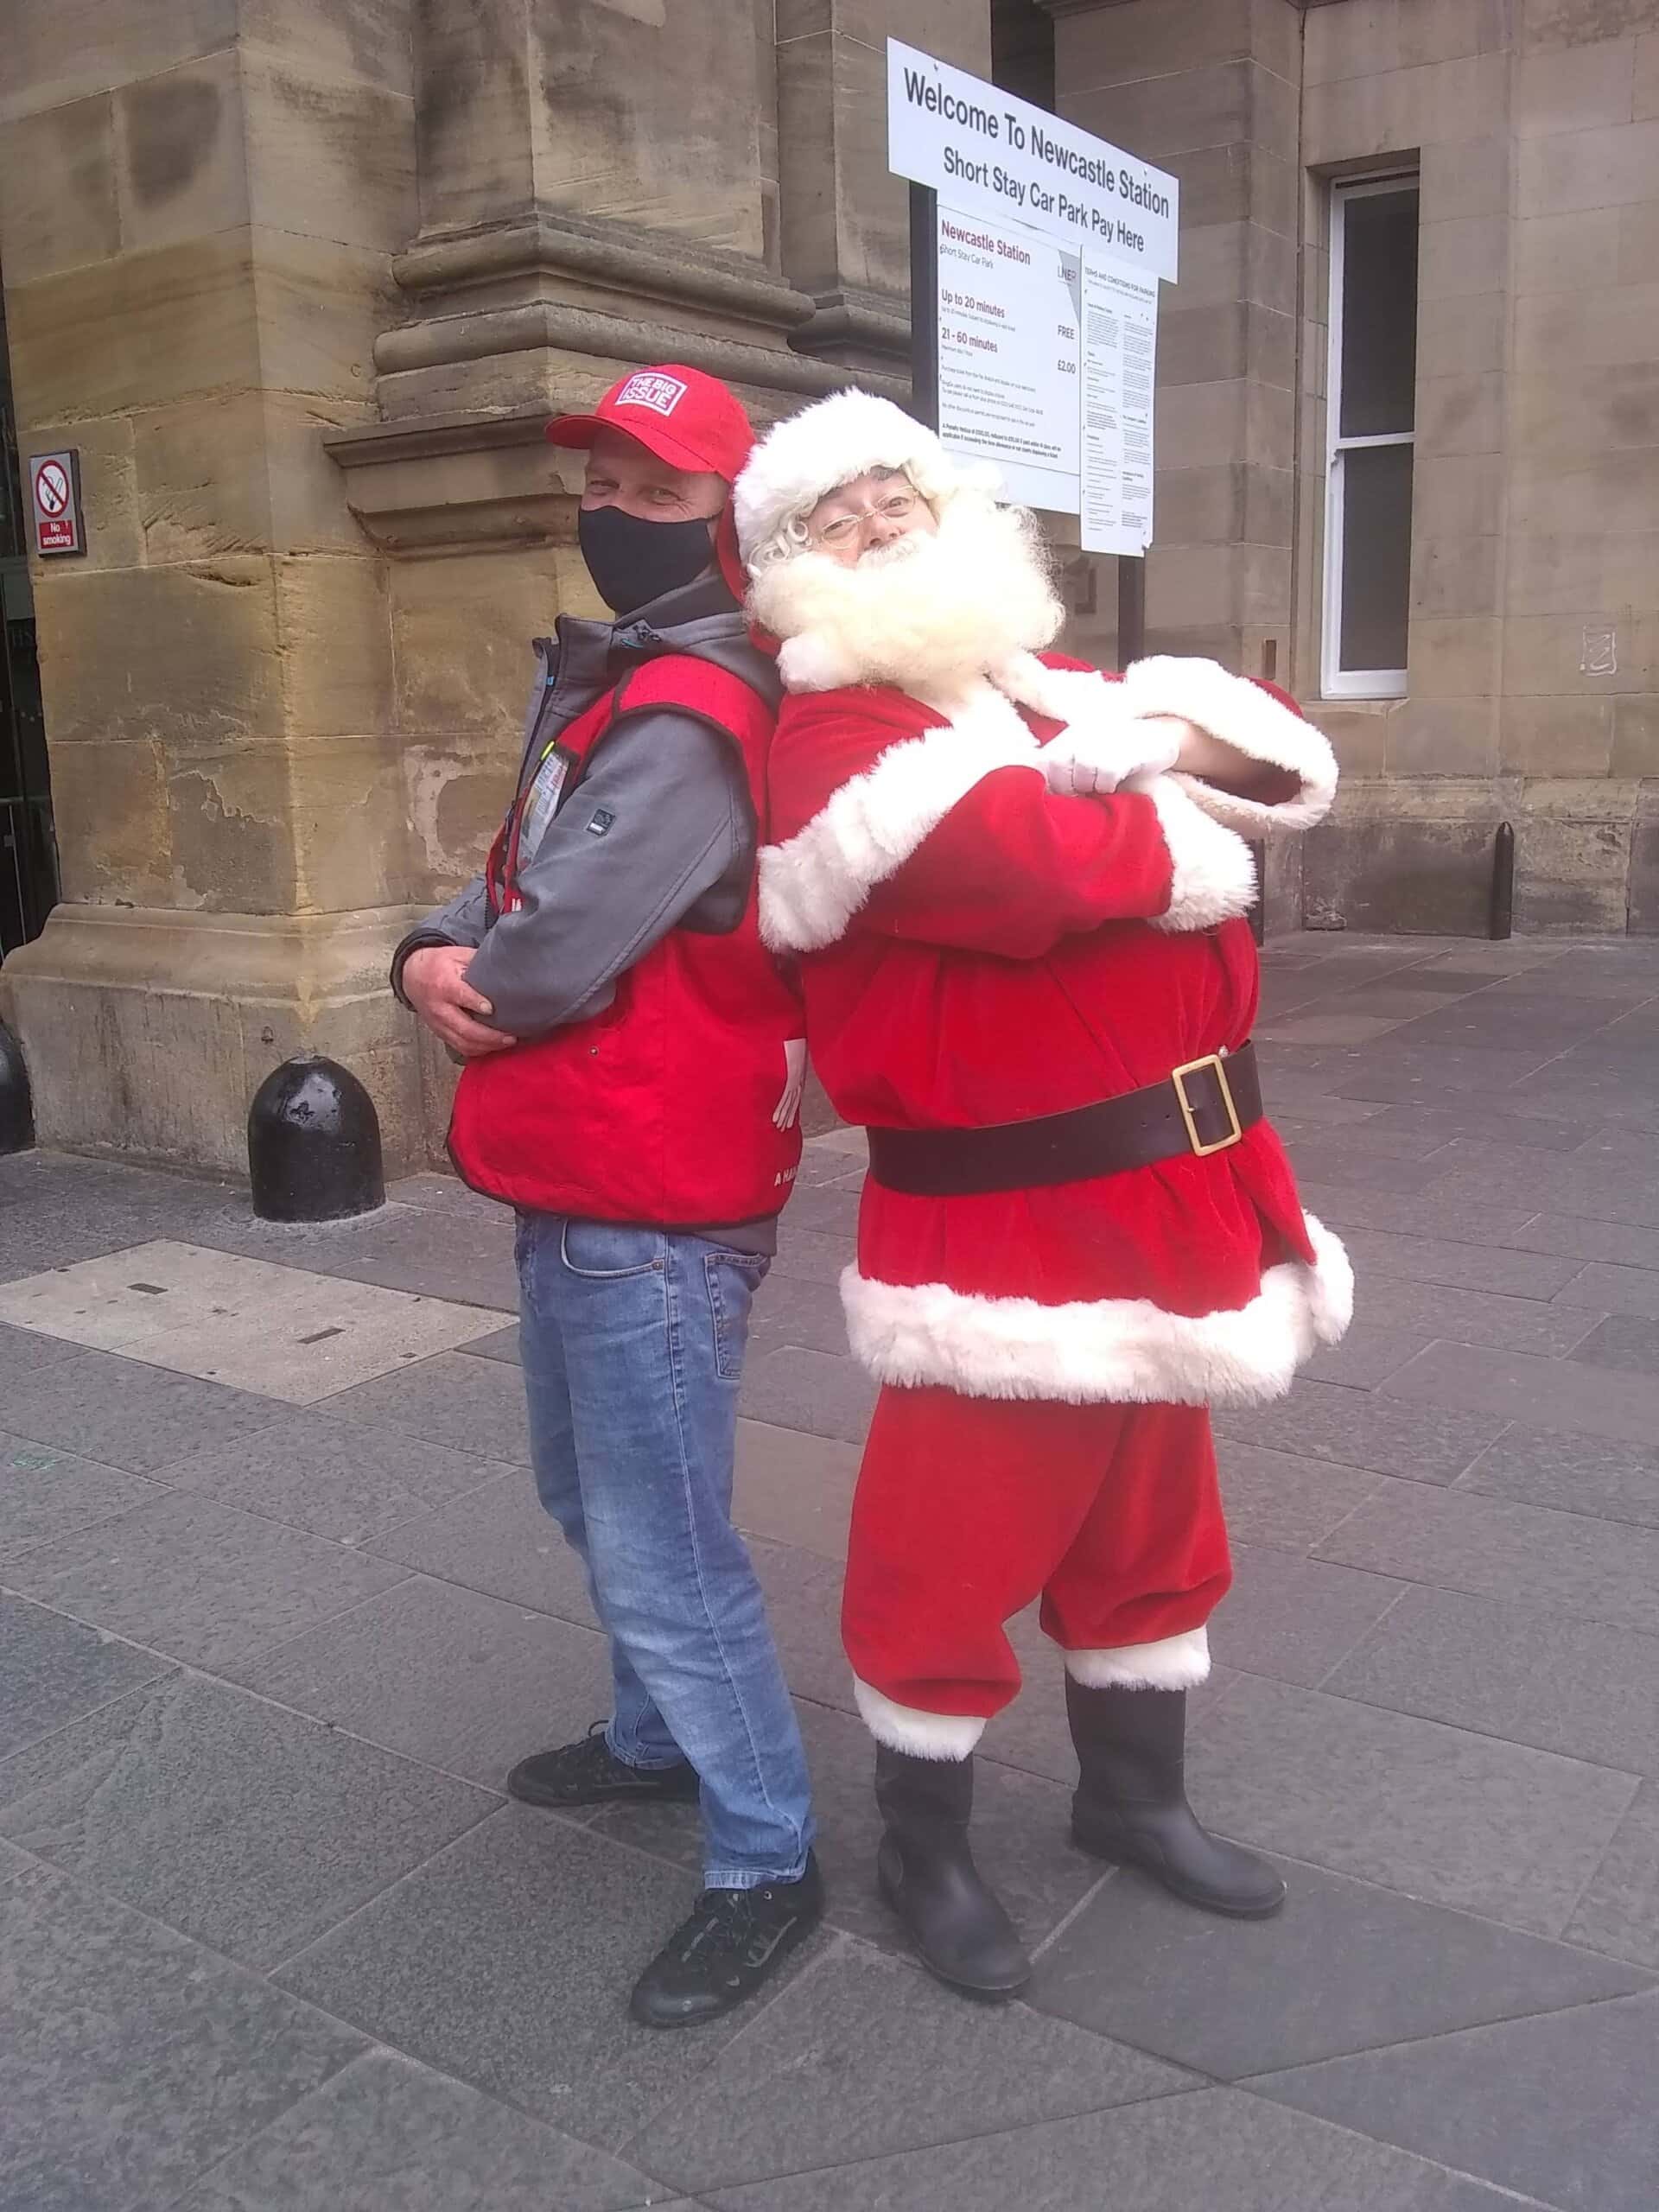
887 40 1179 553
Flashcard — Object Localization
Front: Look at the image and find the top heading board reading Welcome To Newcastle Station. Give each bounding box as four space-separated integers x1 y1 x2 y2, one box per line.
887 38 1179 281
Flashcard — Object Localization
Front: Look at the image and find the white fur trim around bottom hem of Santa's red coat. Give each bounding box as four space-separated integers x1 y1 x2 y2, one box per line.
841 1214 1354 1405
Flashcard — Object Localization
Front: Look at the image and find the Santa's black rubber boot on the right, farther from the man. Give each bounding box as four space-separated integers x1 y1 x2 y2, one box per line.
1066 1675 1285 1920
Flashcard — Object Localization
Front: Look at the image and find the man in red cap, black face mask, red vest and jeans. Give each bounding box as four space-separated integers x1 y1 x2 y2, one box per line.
391 363 823 2029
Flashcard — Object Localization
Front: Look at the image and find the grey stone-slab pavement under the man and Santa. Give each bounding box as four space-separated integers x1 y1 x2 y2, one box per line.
0 936 1659 2212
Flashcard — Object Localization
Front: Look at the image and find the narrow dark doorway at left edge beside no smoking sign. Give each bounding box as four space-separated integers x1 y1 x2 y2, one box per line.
0 263 58 953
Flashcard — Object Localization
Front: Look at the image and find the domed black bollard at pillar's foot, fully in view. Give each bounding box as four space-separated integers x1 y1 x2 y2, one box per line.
248 1053 385 1221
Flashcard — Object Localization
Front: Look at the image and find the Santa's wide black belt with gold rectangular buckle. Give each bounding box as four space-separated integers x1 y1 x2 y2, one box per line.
865 1044 1263 1199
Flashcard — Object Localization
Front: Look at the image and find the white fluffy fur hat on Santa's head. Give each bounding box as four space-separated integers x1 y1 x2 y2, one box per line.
732 387 995 562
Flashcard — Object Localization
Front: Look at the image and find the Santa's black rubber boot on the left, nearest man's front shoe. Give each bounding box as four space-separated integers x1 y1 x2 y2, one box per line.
876 1743 1031 1999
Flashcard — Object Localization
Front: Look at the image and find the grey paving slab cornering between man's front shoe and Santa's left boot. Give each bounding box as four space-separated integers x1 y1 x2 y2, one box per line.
628 1940 1185 2192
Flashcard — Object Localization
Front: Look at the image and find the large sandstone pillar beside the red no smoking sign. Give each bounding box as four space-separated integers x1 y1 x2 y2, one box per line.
0 0 429 1170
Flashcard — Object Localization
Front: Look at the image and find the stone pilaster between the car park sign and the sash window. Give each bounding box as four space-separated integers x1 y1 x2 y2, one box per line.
1042 0 1300 677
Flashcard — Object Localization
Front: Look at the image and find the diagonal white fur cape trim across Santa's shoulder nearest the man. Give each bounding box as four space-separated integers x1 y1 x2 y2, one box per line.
761 679 1044 953
